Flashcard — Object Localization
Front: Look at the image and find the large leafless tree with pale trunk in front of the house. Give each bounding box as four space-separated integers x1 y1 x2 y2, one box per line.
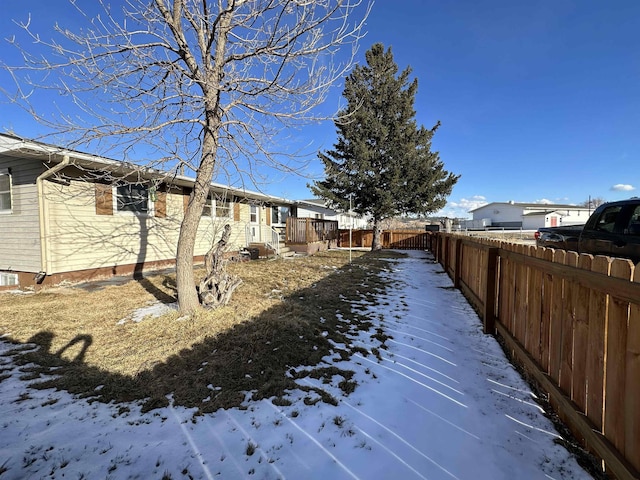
5 0 370 313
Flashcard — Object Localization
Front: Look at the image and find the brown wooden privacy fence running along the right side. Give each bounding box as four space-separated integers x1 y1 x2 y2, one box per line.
429 234 640 479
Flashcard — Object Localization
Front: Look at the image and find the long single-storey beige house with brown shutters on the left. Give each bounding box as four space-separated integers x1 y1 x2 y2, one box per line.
0 134 295 288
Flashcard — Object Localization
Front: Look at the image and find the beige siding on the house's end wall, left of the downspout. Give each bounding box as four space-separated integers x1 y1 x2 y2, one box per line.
0 156 44 273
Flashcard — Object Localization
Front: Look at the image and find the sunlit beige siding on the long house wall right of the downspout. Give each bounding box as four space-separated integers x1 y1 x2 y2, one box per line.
46 180 248 273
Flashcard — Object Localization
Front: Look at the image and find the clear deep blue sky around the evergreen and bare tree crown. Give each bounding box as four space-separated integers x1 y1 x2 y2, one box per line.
0 0 640 216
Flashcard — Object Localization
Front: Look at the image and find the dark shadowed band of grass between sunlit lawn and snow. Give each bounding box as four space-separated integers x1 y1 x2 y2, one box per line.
2 253 396 414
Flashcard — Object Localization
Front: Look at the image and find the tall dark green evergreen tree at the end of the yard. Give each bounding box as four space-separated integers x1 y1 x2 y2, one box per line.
310 43 459 250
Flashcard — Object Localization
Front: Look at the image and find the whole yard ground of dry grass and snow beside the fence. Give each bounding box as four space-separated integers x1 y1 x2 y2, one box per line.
0 251 598 480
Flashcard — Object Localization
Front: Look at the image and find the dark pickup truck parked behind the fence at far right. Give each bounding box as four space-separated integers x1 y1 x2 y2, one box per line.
535 197 640 264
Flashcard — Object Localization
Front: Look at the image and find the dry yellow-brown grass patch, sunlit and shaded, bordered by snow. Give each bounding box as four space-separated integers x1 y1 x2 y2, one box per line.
0 251 404 411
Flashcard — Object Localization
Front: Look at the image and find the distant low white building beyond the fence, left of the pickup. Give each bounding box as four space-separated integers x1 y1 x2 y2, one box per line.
460 201 591 230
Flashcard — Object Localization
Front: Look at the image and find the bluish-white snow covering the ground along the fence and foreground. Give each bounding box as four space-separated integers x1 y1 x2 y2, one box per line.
0 252 590 480
